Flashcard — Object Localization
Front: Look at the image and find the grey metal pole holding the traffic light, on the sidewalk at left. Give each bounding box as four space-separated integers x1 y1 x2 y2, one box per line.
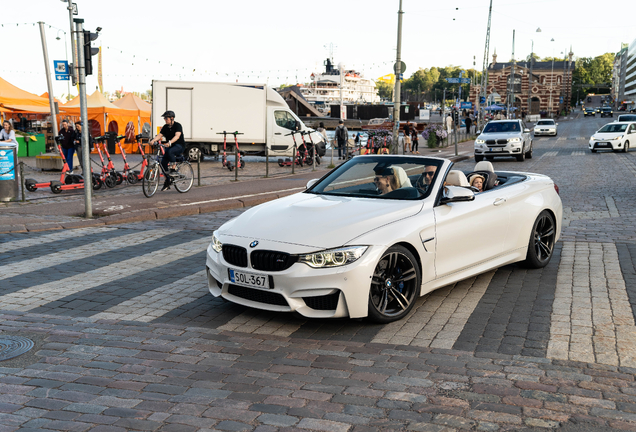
73 18 93 219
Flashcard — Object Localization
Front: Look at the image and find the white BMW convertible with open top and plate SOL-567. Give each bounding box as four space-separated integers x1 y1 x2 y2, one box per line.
206 155 562 322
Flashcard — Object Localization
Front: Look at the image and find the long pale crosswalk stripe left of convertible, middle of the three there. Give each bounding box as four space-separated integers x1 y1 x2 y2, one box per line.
0 237 210 312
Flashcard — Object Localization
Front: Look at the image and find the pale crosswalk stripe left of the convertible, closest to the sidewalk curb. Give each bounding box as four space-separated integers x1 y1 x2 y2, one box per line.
0 230 179 280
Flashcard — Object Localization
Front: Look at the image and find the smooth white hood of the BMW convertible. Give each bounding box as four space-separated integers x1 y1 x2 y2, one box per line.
218 193 423 250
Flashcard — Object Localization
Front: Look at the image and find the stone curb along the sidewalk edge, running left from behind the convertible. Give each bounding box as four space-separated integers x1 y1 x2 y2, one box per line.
0 155 473 234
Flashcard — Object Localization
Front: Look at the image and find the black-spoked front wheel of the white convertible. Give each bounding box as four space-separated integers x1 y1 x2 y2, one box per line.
369 246 422 323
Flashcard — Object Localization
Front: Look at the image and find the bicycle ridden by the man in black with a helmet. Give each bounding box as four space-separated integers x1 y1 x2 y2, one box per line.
142 144 194 198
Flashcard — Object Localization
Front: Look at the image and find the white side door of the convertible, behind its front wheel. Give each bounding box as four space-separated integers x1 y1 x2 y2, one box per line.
434 189 510 278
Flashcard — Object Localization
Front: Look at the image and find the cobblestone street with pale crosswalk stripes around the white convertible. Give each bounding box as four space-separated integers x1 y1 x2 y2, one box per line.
0 115 636 432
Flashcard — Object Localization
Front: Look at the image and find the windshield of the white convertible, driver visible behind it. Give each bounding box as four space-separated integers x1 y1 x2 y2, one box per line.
307 156 443 200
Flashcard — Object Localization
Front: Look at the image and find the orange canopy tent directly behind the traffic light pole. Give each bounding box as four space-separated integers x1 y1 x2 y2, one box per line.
63 90 138 153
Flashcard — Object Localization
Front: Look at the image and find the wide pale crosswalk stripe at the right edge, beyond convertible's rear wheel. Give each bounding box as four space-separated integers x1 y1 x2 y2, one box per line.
547 242 636 367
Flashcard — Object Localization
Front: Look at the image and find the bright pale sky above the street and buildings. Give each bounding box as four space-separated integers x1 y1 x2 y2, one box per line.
0 0 636 98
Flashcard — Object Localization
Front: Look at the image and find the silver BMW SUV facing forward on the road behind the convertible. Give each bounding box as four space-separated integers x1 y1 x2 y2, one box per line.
475 120 532 162
